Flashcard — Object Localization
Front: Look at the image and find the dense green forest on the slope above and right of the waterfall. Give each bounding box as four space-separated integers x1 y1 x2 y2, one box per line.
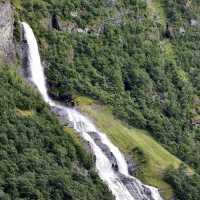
0 0 200 200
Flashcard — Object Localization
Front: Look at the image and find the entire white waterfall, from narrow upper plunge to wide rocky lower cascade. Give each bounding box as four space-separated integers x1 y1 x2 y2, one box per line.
22 22 163 200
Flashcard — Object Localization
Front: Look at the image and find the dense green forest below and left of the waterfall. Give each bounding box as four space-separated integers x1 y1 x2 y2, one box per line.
0 65 113 200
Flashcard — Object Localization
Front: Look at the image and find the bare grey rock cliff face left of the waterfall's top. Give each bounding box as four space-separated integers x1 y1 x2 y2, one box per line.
0 1 14 61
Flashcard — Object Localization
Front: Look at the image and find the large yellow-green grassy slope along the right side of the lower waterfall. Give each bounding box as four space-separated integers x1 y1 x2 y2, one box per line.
80 105 184 199
